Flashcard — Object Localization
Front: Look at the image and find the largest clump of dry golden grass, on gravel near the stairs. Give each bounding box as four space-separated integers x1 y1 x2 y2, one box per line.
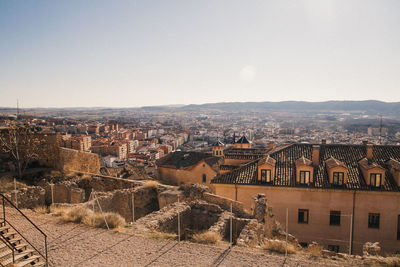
50 206 126 229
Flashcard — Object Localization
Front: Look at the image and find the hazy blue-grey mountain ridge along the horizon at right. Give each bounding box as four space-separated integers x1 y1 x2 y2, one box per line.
141 100 400 116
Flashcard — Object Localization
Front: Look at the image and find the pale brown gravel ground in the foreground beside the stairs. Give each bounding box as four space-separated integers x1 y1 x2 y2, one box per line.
14 211 348 266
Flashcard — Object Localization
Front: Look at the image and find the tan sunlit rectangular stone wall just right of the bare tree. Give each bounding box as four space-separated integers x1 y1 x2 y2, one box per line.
57 147 100 173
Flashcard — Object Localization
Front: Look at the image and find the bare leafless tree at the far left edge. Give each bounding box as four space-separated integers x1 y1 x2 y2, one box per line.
0 122 45 178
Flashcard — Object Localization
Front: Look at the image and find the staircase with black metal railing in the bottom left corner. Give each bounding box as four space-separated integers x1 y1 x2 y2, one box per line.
0 194 48 267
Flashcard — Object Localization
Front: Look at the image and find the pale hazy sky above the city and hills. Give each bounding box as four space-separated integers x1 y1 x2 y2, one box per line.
0 0 400 107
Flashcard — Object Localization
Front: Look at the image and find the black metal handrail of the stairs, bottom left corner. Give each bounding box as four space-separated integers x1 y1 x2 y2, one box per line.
0 193 48 266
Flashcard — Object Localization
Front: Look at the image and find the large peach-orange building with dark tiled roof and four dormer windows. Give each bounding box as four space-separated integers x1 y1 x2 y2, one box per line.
211 144 400 254
